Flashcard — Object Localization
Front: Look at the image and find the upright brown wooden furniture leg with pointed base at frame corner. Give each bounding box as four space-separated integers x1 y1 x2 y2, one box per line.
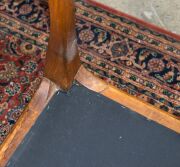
45 0 80 91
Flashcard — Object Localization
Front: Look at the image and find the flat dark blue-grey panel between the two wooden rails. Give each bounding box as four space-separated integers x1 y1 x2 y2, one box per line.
8 86 180 167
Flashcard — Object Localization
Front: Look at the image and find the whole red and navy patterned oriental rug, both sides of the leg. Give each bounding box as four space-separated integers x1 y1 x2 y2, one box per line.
0 0 180 145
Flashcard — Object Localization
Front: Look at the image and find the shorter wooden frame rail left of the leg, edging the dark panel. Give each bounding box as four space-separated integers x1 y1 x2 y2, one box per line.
0 78 59 167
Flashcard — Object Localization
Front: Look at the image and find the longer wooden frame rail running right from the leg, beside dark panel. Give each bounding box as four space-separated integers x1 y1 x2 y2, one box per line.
76 66 180 133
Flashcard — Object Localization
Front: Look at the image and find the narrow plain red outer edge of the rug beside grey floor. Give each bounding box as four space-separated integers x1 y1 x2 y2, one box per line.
84 0 180 40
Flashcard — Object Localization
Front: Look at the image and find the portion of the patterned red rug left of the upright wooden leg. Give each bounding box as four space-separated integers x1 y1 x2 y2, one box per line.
0 0 48 145
